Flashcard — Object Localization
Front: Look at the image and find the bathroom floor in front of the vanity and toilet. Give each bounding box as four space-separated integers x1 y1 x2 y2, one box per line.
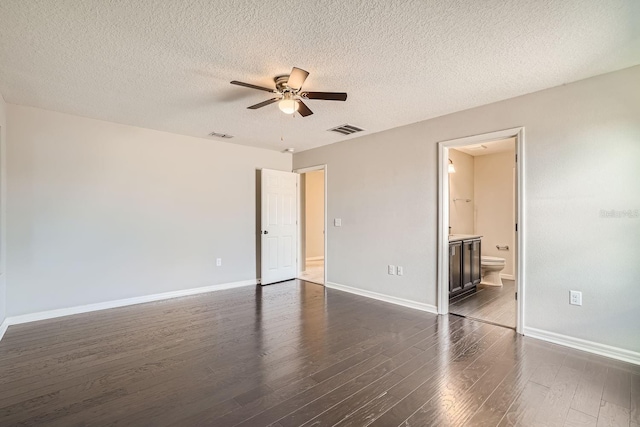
449 279 516 328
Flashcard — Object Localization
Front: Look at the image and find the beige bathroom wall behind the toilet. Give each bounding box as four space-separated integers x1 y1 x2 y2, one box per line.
473 150 515 279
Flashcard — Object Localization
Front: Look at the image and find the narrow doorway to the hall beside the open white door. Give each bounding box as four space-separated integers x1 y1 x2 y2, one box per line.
295 165 326 285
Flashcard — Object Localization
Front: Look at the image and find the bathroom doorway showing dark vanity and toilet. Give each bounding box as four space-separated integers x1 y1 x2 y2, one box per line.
438 129 524 332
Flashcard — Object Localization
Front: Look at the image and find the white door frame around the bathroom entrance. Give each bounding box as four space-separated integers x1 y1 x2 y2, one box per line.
438 126 526 334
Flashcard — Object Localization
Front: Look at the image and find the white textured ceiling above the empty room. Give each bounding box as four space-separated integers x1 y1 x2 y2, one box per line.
0 0 640 151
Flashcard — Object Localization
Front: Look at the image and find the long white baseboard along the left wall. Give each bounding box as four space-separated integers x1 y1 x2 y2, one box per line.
0 279 257 339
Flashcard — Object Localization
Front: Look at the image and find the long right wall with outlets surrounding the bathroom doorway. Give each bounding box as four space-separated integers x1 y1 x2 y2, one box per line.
294 66 640 352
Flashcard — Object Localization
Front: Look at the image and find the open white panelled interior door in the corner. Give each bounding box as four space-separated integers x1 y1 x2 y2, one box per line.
260 169 298 285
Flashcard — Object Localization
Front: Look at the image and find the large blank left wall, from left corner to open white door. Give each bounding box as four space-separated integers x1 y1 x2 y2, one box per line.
7 105 291 316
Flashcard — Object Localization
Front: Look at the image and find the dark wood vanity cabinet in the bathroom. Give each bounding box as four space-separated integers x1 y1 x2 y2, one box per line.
449 239 481 297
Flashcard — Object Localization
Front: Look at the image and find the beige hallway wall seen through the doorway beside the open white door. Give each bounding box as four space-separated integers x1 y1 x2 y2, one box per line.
304 170 324 259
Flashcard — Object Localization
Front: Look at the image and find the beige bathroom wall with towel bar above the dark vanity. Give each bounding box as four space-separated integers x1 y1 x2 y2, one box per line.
449 149 474 234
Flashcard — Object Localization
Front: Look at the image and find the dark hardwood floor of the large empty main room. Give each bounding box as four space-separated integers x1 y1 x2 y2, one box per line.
0 281 640 427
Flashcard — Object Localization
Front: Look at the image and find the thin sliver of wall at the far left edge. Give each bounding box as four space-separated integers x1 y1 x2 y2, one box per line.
0 94 7 328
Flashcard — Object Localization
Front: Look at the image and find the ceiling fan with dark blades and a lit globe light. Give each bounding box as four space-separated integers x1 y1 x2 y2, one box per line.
231 67 347 117
